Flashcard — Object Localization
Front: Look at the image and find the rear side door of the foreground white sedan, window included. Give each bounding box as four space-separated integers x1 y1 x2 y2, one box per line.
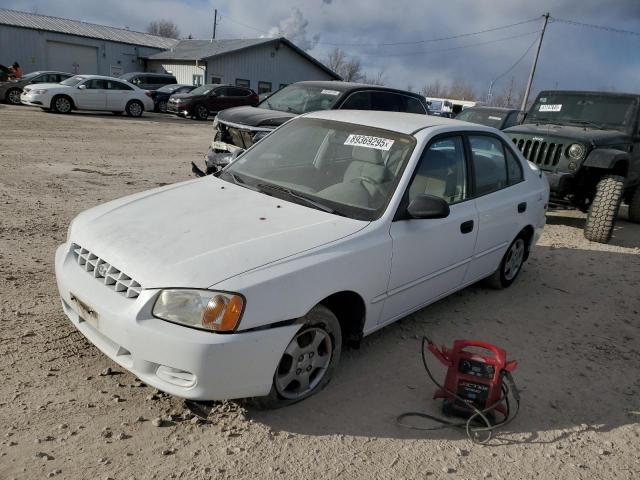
465 134 535 282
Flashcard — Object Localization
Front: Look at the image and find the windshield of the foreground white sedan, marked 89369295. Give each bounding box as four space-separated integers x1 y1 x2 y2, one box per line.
220 118 415 220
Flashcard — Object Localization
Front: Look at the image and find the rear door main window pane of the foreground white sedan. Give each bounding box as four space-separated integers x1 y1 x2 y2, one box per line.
469 135 507 195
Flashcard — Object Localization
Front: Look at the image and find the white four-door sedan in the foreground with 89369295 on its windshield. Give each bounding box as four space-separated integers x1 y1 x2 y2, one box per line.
55 111 549 407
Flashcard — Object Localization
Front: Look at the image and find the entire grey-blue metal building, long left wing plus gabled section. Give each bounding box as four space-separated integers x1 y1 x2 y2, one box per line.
0 9 340 93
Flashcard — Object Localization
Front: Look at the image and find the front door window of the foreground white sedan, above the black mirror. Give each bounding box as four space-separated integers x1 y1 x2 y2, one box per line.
409 136 468 204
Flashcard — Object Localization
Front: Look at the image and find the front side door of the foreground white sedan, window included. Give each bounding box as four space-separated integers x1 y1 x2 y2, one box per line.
381 135 478 323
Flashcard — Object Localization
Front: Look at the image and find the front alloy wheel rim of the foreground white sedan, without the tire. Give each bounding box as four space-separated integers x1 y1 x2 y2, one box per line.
275 327 333 400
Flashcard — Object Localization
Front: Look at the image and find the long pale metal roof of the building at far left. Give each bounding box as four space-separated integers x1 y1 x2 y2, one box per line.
0 8 178 49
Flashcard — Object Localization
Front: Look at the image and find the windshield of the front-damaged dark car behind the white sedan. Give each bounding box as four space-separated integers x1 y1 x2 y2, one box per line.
259 85 342 114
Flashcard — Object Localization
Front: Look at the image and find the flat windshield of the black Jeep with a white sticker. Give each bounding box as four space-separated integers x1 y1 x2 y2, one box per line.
525 92 638 130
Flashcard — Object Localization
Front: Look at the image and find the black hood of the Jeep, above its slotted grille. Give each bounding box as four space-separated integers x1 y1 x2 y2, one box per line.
505 123 629 145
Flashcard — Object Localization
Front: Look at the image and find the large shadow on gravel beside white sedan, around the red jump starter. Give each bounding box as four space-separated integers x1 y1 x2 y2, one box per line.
249 247 640 443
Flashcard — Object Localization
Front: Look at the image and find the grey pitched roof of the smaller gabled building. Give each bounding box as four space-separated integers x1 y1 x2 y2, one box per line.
147 37 340 80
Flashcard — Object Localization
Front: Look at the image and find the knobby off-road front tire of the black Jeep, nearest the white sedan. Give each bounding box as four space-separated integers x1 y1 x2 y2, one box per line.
584 175 624 243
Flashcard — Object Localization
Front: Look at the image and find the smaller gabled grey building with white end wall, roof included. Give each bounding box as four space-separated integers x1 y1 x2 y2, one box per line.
147 38 340 93
